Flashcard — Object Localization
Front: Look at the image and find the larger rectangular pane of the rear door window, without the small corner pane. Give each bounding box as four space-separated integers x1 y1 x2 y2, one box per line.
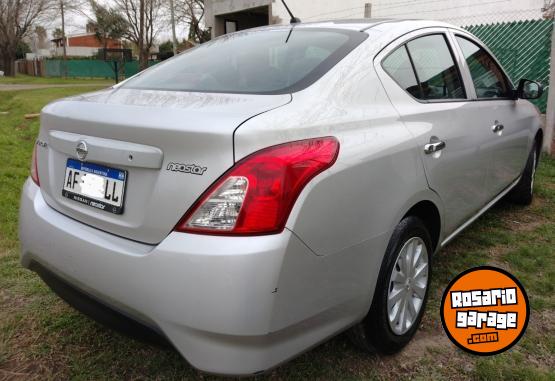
407 34 466 100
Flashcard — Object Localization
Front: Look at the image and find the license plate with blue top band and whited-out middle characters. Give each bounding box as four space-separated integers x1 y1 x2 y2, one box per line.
62 159 127 214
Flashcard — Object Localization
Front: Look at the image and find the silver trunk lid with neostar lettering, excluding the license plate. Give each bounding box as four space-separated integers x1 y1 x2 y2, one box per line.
37 89 291 243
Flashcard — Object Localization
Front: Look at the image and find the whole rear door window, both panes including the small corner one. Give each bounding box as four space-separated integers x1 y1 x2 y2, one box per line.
382 34 466 100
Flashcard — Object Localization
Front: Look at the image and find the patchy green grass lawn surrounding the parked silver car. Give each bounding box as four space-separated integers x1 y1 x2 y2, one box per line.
0 84 555 380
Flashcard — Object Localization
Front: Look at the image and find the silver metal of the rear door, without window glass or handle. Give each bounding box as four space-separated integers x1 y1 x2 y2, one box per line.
374 28 494 233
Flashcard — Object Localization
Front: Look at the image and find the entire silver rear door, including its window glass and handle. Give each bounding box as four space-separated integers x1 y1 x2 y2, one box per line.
374 28 492 234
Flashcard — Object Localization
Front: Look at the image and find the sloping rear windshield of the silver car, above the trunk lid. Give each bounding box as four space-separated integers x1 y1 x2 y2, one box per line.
123 28 368 94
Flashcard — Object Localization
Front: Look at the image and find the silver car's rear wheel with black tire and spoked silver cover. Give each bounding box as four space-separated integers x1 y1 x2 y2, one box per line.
349 216 433 354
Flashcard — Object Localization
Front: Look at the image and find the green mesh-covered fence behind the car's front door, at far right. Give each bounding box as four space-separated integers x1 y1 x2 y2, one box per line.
465 20 553 112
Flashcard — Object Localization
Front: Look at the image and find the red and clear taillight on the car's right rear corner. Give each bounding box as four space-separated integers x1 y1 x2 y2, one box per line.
175 137 339 235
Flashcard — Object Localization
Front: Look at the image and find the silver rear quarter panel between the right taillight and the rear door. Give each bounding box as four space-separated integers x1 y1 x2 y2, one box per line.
235 33 434 255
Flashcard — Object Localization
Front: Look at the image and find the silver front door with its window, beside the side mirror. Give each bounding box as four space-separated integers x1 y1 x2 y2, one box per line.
453 31 534 199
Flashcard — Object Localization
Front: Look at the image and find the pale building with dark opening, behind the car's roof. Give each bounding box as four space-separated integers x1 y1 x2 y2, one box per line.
205 0 549 37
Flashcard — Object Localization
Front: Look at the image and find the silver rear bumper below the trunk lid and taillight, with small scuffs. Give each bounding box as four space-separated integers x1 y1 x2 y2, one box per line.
20 180 373 375
